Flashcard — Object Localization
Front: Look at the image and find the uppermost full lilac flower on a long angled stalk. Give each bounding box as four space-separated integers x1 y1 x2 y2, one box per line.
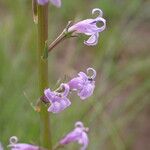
68 8 106 46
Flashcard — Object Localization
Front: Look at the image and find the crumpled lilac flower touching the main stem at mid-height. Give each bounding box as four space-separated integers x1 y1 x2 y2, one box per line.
44 84 71 113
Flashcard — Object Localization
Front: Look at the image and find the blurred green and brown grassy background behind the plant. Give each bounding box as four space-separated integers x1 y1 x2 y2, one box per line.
0 0 150 150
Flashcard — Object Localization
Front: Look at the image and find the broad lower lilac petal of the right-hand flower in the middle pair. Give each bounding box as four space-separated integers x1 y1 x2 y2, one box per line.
78 83 95 100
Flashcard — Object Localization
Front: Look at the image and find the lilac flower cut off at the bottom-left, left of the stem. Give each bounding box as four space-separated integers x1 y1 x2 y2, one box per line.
8 136 39 150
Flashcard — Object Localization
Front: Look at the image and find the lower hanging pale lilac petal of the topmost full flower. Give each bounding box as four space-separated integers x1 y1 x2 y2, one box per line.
84 33 99 46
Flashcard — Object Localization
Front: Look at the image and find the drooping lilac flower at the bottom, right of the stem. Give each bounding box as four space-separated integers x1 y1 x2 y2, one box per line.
59 121 89 150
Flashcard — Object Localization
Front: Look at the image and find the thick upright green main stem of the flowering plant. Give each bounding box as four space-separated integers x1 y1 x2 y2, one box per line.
37 4 52 150
